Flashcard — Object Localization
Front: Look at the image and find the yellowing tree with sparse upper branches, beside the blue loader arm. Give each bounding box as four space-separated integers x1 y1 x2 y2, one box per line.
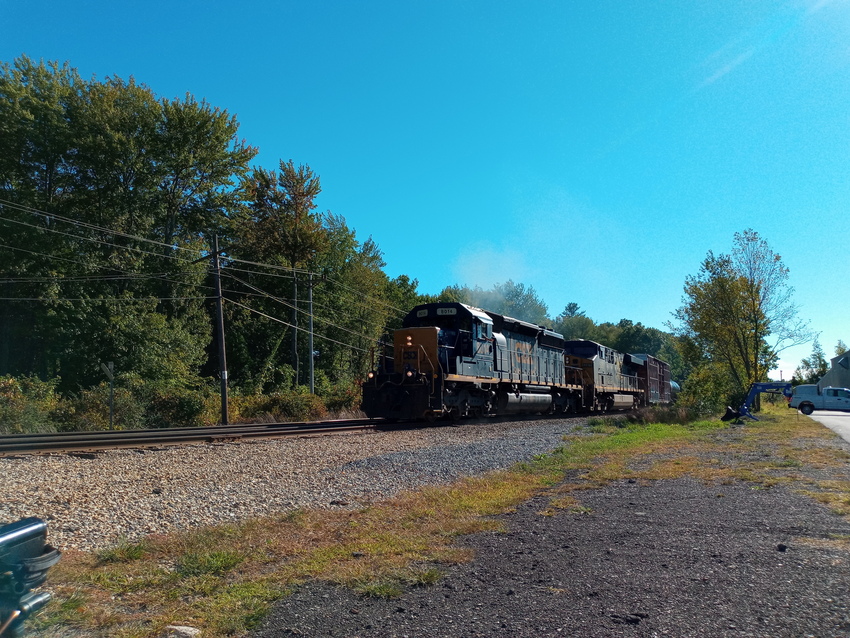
671 229 811 400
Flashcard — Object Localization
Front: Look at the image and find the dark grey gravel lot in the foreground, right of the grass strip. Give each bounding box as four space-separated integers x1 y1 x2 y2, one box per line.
255 426 850 638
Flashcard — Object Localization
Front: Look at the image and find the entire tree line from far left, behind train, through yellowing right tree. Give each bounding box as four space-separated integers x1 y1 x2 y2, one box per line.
0 56 828 427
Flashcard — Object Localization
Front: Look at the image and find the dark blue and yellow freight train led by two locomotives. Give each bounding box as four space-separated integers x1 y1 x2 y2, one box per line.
361 302 672 420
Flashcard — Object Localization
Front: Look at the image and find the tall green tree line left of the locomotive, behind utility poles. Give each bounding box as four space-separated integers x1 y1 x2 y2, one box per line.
0 57 419 430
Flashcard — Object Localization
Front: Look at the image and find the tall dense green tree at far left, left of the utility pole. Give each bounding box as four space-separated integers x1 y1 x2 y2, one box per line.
0 57 256 391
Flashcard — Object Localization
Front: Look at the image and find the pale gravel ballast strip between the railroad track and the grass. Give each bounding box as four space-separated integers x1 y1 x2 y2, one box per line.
0 419 581 550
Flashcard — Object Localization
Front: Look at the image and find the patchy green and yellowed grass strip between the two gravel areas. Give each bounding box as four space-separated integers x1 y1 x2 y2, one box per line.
30 408 850 638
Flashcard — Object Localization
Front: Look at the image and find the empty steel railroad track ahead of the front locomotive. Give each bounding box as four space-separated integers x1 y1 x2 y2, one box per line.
0 419 388 456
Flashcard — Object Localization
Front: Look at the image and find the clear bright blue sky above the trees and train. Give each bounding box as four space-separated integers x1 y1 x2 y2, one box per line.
0 0 850 378
